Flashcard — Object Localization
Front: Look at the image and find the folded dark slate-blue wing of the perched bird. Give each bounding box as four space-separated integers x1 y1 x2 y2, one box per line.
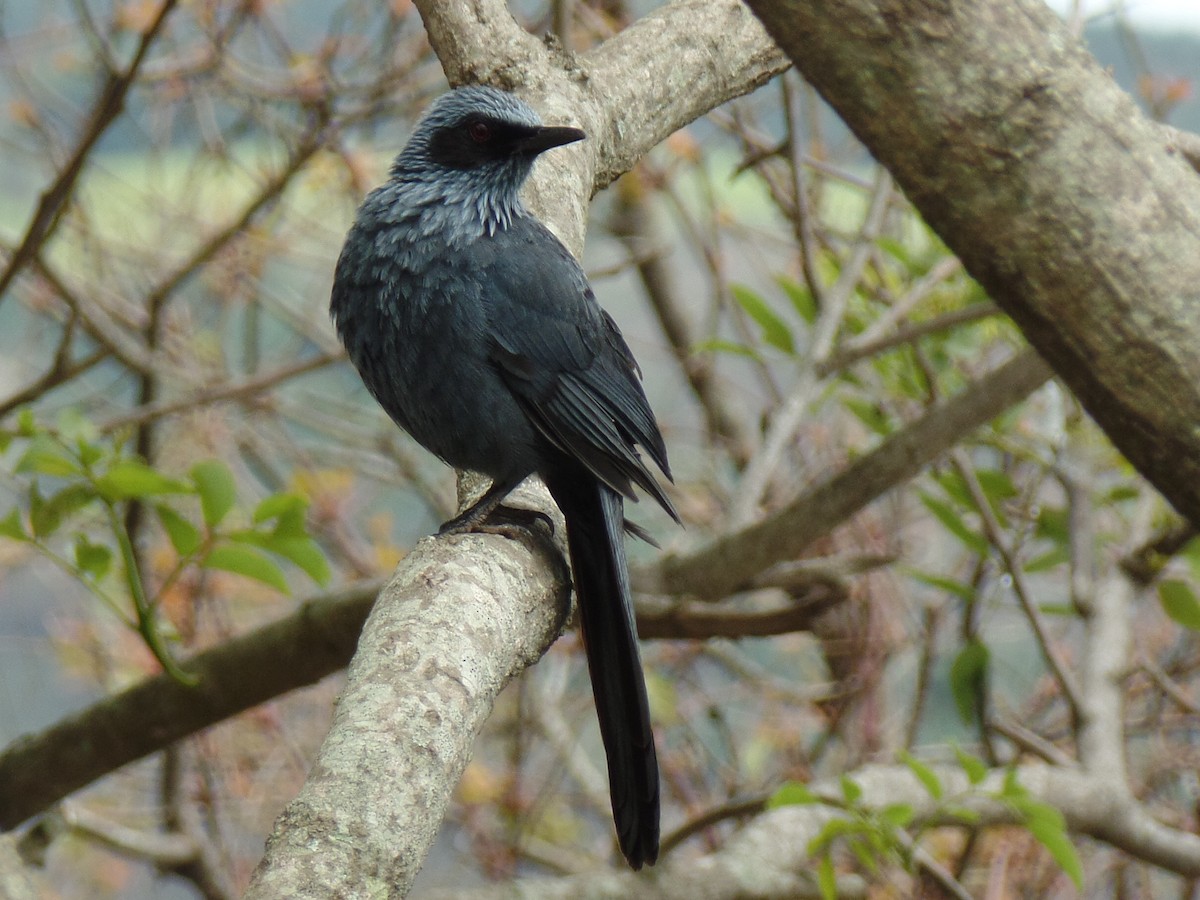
481 217 678 518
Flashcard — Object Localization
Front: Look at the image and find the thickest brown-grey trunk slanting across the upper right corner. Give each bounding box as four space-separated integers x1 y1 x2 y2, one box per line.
748 0 1200 522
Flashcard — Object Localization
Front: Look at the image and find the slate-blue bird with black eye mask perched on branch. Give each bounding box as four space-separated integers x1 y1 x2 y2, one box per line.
330 86 679 869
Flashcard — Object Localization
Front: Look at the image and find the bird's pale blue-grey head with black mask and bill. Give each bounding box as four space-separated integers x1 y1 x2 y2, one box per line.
392 86 584 210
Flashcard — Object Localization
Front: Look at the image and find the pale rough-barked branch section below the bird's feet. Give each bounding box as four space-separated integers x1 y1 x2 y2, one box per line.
246 534 568 900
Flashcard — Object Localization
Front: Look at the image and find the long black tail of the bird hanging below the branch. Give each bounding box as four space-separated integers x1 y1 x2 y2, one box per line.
546 468 659 869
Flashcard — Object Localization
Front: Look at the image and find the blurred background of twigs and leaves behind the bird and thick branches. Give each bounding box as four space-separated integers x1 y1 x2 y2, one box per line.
0 0 1200 898
